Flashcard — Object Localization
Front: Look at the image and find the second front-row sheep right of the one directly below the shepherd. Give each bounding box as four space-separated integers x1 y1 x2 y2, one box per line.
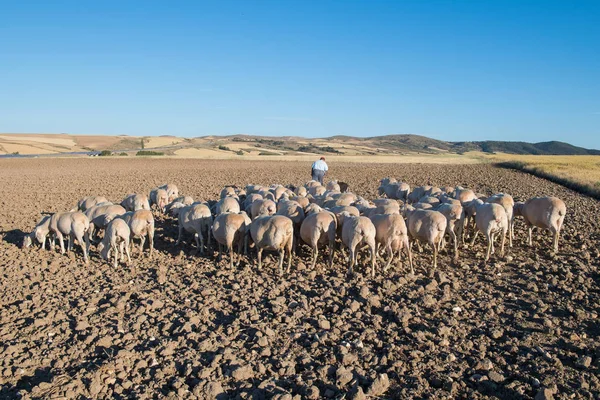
370 214 415 275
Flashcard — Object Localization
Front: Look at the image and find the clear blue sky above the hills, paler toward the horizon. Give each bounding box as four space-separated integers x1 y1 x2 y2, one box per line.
0 0 600 148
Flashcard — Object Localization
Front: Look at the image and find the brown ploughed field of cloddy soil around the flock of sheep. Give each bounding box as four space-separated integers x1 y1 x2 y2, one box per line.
0 159 600 399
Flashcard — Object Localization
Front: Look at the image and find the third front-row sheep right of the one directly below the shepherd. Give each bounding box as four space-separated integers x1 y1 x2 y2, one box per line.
404 206 447 276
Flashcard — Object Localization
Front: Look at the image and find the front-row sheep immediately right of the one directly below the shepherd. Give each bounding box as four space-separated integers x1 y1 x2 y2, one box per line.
341 212 376 277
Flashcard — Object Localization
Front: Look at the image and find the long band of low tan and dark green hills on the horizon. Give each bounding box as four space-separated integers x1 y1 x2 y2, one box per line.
0 133 600 157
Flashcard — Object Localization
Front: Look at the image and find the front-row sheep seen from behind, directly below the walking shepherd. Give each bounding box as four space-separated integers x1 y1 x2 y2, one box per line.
300 211 338 269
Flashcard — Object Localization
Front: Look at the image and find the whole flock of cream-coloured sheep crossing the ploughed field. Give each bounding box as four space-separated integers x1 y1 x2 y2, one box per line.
23 178 566 276
